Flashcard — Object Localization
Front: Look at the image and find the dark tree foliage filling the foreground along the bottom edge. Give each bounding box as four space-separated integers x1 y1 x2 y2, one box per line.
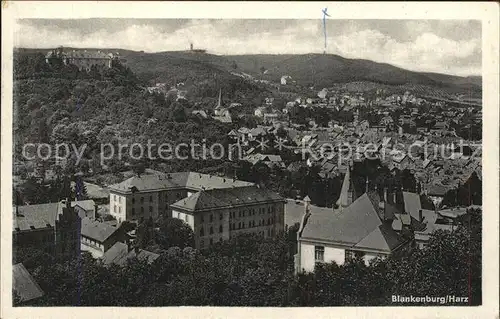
18 211 482 306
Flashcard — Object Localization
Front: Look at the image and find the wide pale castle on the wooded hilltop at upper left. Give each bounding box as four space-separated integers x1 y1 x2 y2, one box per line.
45 47 119 72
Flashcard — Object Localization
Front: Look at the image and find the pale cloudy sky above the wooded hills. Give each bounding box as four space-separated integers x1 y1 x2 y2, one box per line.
14 18 482 76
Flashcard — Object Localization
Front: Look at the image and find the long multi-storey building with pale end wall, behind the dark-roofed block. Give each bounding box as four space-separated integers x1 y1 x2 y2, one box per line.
109 170 253 222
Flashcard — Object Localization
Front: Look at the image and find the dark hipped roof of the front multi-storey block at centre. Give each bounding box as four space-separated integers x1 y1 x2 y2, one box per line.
171 186 284 211
